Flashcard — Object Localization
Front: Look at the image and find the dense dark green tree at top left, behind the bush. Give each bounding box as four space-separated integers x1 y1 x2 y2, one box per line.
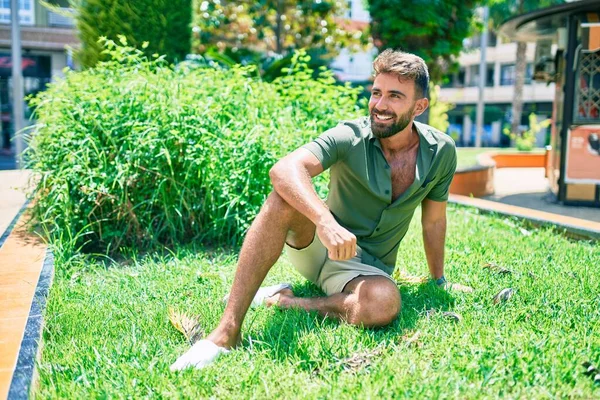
54 0 192 67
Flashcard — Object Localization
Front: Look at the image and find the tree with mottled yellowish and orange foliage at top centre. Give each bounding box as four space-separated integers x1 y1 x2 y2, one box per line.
192 0 368 64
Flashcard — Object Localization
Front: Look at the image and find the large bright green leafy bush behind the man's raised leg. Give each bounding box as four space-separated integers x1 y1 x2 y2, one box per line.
28 37 359 254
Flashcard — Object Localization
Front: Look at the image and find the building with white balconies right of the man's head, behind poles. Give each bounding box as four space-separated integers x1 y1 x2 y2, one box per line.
440 33 555 147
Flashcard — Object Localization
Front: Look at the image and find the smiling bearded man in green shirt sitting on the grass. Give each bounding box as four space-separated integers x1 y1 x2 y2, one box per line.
171 50 468 370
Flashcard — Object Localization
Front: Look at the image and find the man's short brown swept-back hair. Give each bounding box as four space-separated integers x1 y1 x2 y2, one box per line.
373 49 429 97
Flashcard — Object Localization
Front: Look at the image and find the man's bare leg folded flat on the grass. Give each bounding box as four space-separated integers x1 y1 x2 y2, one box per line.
267 276 401 327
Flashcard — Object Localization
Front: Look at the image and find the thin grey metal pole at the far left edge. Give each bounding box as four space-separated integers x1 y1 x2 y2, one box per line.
10 0 25 169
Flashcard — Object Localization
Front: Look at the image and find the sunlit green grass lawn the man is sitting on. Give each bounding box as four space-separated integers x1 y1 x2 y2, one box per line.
35 206 600 399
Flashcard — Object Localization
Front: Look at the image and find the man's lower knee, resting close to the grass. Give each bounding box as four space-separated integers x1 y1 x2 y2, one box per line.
348 277 402 327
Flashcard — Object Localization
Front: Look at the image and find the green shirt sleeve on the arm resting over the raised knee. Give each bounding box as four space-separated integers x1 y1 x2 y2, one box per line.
302 124 356 170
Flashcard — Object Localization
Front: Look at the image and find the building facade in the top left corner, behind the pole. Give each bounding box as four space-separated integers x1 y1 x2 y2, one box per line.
0 0 78 153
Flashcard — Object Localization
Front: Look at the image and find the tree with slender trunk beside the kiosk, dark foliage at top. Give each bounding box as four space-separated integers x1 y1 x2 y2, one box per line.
490 0 564 134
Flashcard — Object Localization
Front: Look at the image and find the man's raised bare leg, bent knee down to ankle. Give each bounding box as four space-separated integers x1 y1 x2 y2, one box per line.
207 192 316 348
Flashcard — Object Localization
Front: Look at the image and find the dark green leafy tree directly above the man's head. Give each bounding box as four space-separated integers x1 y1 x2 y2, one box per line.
369 0 480 82
